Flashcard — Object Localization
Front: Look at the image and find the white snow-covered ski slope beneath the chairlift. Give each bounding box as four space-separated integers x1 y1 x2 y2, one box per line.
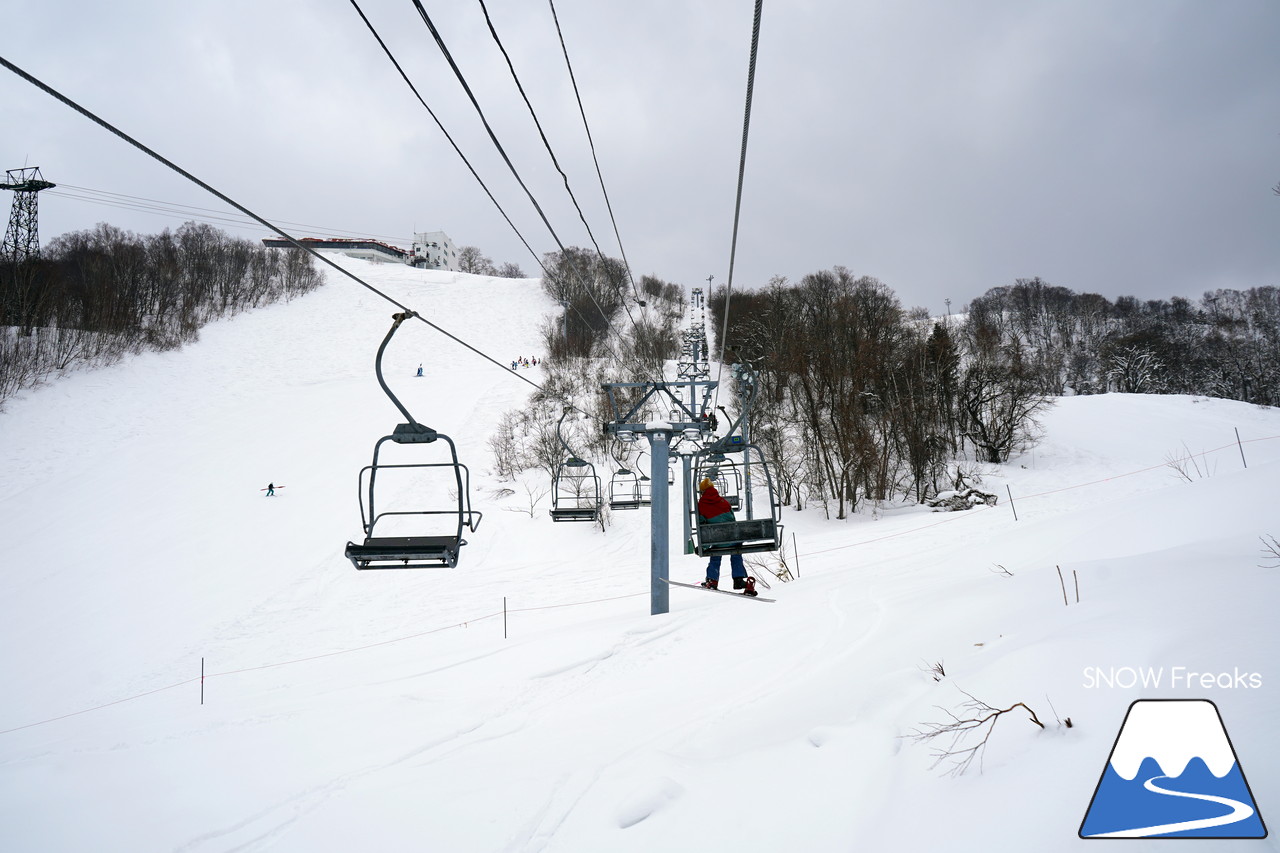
0 261 1280 853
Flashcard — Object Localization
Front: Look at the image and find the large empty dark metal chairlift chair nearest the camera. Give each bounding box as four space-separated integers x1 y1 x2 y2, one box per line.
344 308 481 569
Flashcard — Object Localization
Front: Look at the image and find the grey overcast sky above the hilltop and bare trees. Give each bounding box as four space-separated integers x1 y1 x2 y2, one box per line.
0 0 1280 313
